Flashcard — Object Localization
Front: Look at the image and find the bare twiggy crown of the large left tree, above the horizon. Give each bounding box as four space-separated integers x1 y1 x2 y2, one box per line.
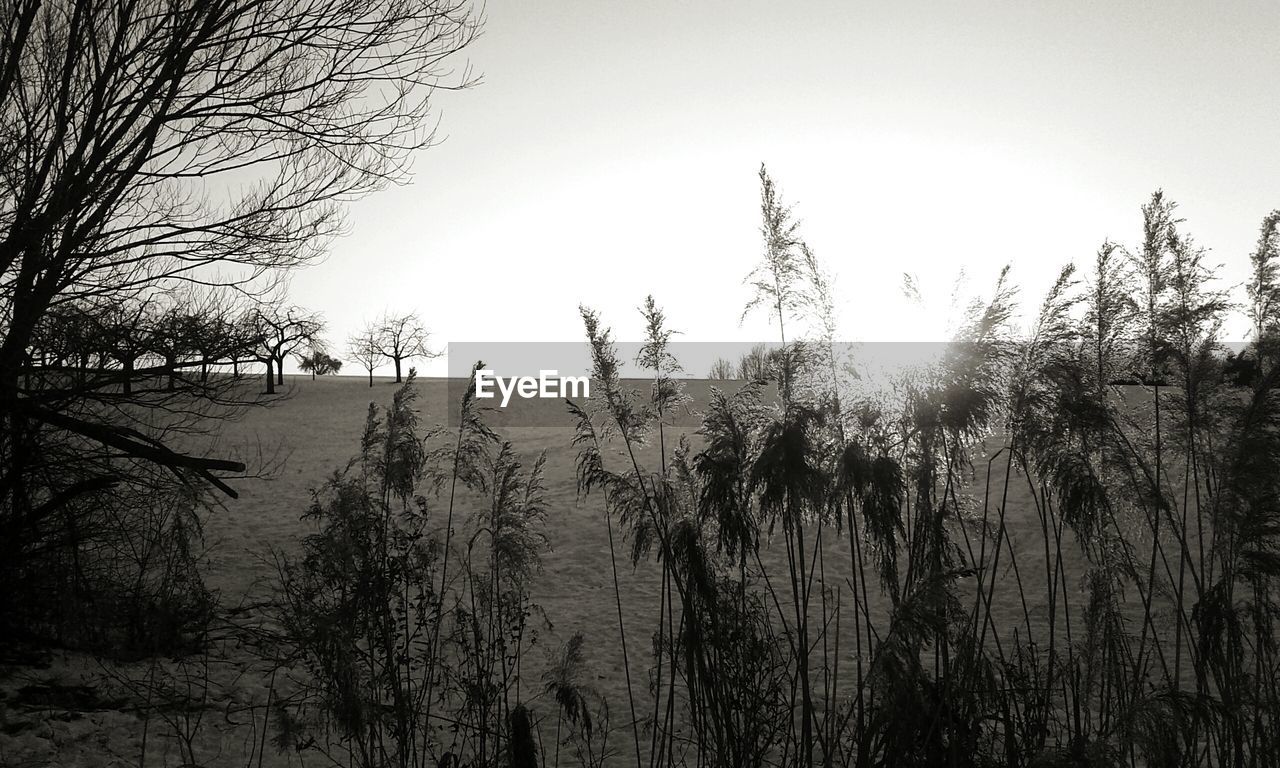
0 0 475 394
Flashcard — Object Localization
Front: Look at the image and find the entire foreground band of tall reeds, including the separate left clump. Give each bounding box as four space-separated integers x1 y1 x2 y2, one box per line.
262 183 1280 768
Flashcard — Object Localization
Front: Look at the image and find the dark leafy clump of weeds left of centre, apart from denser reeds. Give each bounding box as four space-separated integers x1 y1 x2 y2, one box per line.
278 375 547 767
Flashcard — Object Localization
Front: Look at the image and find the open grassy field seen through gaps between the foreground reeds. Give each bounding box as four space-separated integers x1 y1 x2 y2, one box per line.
206 376 1046 691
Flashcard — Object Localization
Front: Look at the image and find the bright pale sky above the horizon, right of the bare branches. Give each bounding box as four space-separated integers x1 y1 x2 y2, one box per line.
292 0 1280 374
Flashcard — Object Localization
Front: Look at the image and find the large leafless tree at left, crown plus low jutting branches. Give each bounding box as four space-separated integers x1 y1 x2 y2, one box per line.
0 0 476 647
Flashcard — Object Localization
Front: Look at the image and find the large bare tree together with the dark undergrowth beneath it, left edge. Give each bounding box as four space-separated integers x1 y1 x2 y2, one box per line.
0 0 477 653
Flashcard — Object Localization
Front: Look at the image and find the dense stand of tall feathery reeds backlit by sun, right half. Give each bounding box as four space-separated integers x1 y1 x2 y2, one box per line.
575 181 1280 767
